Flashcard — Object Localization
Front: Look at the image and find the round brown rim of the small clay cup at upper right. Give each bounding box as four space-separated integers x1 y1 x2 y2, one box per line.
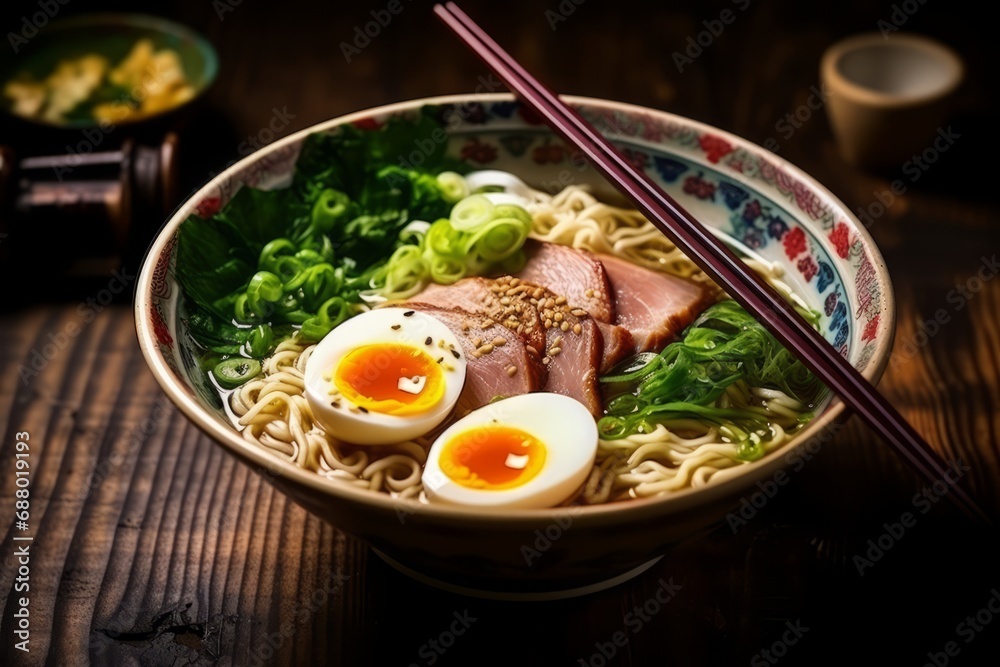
820 32 965 108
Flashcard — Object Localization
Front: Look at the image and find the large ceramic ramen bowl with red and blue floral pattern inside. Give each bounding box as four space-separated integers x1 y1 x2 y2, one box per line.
135 94 895 599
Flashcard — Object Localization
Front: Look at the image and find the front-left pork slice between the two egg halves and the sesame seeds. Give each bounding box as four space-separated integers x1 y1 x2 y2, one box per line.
407 302 548 417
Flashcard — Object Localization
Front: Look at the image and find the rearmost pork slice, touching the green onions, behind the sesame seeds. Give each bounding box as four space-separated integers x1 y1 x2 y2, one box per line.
517 239 615 323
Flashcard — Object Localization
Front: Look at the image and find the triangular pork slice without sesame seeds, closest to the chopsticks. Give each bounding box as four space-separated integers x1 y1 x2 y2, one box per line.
597 255 712 352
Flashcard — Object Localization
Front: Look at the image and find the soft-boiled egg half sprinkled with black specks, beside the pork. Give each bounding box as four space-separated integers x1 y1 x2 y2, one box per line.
305 308 466 445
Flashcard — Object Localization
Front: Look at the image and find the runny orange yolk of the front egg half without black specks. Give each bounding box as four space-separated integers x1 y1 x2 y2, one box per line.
440 425 545 490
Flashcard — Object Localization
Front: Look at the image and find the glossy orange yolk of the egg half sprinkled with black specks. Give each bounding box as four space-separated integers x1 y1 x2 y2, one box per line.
333 343 444 416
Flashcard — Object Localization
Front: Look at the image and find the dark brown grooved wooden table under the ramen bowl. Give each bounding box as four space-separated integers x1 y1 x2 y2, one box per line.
0 0 1000 666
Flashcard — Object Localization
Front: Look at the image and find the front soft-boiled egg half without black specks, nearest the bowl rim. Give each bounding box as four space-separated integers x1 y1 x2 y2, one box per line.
422 392 597 508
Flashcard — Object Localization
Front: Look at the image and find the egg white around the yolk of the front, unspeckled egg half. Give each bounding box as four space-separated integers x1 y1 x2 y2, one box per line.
422 392 597 508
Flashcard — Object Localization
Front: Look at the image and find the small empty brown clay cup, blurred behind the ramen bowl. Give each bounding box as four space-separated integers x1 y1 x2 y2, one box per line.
820 32 965 166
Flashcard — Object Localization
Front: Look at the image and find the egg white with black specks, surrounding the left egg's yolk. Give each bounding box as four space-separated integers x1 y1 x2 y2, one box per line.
305 308 466 445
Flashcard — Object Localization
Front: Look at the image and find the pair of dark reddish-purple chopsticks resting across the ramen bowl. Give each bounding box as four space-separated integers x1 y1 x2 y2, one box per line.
434 2 992 524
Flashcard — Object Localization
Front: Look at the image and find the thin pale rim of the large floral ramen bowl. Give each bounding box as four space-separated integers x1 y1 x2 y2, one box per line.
133 93 896 526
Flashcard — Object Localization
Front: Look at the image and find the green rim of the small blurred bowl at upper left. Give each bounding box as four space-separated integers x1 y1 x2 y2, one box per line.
3 12 217 130
